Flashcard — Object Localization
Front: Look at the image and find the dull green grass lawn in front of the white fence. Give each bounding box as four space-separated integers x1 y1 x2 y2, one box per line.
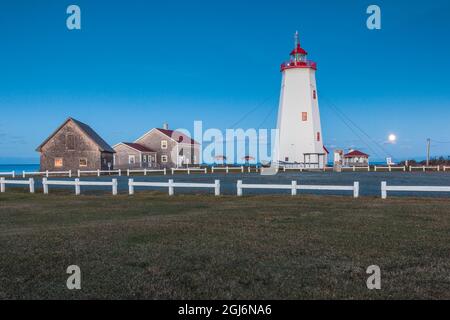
0 189 450 299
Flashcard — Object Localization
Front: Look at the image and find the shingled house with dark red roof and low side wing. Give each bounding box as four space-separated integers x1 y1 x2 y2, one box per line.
114 125 200 168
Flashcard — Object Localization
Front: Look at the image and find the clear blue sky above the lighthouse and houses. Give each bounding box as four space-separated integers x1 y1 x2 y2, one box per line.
0 0 450 163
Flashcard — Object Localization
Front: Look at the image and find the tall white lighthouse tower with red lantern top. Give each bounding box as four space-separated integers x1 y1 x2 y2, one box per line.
276 32 326 168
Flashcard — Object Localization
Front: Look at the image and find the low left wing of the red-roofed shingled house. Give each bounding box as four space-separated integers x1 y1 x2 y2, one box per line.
113 142 158 169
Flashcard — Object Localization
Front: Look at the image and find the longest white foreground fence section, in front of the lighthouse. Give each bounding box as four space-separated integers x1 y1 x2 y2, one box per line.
236 180 359 198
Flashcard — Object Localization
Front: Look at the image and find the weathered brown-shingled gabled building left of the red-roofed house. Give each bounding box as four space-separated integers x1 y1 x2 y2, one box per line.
36 118 115 171
